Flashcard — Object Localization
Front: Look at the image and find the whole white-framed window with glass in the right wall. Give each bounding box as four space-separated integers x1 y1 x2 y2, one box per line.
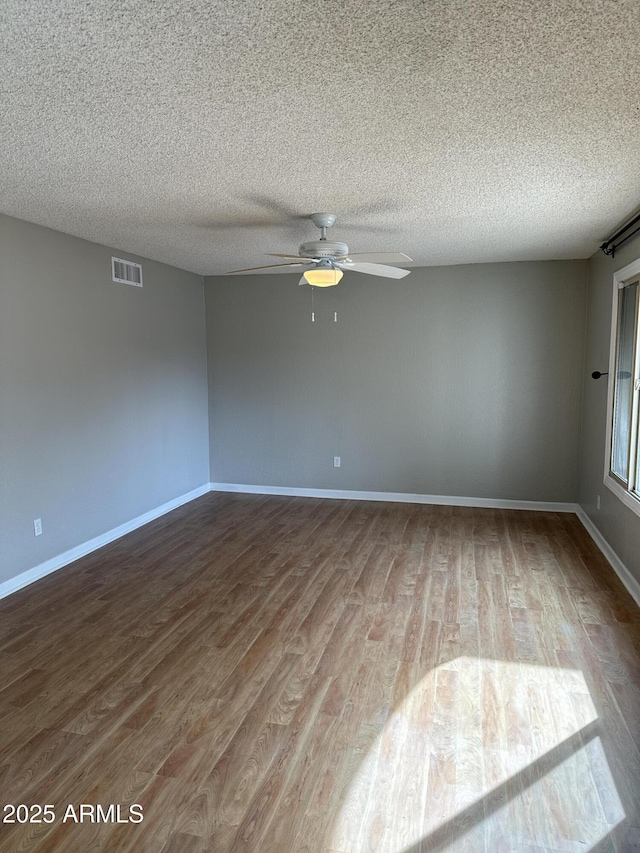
605 259 640 515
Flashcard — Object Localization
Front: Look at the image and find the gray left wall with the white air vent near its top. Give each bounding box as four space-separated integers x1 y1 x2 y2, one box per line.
0 216 209 582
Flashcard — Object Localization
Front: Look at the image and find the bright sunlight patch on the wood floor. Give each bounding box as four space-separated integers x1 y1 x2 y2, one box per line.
329 657 624 853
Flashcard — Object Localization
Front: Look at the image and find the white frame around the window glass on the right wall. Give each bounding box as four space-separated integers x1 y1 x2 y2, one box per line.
604 258 640 516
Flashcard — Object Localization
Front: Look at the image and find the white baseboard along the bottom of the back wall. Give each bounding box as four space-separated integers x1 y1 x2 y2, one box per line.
209 483 578 512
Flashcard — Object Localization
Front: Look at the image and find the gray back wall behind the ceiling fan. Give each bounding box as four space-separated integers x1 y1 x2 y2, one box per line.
205 261 588 501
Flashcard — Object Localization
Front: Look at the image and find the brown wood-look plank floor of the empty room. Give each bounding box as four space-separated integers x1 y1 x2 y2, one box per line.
0 494 640 853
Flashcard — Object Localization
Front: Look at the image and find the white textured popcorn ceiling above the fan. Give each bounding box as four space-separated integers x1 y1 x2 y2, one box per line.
0 0 640 274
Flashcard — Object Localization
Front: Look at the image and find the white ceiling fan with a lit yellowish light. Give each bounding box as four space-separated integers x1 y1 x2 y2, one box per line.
227 213 411 287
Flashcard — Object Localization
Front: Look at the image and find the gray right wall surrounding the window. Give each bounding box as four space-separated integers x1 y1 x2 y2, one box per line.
579 237 640 582
